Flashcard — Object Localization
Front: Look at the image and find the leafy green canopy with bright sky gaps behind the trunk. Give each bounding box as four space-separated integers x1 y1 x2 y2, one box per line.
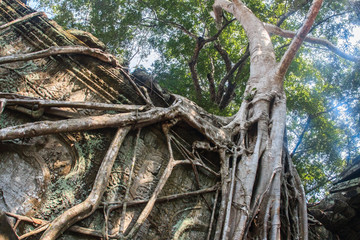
30 0 360 201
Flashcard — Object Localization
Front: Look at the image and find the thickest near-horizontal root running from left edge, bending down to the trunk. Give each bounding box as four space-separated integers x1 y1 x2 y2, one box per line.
0 95 230 144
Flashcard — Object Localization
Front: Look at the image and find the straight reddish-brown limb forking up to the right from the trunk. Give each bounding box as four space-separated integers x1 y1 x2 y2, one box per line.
276 0 323 79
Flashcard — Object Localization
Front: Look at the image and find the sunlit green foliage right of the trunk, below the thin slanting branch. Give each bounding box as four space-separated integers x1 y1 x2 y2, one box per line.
286 47 360 201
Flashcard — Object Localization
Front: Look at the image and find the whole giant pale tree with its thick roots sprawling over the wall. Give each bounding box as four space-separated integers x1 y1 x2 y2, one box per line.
0 0 358 239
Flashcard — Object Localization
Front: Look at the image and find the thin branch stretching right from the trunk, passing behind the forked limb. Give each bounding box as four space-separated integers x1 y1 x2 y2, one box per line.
264 23 360 62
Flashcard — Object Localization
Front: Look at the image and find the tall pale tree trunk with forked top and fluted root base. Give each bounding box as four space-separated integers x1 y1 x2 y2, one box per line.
214 0 322 239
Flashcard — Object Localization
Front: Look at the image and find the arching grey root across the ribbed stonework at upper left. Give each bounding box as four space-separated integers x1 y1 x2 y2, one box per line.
0 46 121 67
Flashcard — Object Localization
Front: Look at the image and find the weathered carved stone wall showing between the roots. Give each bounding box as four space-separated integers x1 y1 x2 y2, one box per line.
0 0 219 239
